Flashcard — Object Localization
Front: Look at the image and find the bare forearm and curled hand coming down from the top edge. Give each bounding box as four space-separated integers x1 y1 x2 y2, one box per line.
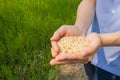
50 0 96 57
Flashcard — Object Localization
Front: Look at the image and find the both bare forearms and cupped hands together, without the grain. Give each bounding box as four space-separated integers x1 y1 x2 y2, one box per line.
50 0 120 65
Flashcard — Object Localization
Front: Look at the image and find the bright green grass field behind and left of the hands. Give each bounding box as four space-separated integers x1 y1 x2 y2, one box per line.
0 0 80 80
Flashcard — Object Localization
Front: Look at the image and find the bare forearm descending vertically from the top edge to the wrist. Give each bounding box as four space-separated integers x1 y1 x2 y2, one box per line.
75 0 96 34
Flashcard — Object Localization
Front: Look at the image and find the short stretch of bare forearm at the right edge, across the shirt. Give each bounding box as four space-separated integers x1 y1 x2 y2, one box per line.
99 32 120 46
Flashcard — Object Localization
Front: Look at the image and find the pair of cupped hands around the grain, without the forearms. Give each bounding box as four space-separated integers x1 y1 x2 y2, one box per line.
50 25 102 65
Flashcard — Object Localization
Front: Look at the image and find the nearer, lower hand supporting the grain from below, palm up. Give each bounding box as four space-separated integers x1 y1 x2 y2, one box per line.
50 33 101 65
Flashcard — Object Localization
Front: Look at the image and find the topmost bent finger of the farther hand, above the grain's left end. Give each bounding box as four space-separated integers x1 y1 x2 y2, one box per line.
50 26 66 41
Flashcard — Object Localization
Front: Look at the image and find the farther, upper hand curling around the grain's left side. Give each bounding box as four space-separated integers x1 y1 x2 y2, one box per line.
50 25 84 57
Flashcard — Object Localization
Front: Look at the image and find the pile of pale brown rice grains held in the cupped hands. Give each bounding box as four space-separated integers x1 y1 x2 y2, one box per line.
58 36 86 53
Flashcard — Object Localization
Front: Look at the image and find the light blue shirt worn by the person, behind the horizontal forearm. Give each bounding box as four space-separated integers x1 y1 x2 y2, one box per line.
92 0 120 76
